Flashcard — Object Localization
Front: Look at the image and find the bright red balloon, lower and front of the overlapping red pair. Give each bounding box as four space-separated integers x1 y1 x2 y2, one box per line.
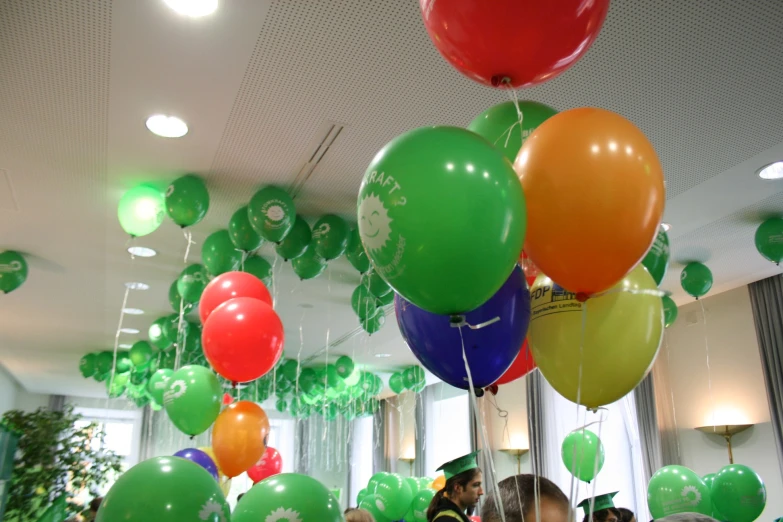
201 297 285 382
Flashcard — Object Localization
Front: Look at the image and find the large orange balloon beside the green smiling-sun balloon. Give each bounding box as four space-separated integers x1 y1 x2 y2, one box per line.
514 108 666 296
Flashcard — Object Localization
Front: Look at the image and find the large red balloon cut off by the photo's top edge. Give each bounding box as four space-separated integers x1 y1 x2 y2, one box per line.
419 0 609 89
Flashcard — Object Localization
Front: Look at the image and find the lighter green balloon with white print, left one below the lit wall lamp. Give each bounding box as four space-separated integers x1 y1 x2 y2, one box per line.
647 466 712 519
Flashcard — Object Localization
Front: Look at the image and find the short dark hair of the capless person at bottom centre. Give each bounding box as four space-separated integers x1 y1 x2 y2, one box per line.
481 474 570 522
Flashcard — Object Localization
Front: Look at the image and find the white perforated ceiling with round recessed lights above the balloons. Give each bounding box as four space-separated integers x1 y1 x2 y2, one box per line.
0 0 783 396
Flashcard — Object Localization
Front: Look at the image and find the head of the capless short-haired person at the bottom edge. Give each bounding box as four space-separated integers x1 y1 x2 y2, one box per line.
481 475 570 522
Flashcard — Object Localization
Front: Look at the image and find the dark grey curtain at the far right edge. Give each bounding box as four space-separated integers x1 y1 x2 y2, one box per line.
748 275 783 482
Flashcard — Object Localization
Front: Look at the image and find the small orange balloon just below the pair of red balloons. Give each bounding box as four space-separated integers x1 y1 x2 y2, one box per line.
212 401 269 478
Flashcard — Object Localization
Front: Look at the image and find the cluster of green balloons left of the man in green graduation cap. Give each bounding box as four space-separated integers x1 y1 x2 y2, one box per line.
356 471 435 522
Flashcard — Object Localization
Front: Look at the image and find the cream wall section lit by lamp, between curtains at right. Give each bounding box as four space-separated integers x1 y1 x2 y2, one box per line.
660 287 783 520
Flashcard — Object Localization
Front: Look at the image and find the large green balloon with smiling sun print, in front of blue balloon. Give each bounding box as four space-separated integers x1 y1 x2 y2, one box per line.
358 127 527 315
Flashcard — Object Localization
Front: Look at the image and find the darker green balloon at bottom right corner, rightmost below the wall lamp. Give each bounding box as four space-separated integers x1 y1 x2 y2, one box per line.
712 464 767 522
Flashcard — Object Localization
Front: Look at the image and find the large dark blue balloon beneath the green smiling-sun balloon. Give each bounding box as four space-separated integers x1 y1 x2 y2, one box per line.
394 266 530 390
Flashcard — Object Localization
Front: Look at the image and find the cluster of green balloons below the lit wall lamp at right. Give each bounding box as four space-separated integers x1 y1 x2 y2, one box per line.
647 464 767 522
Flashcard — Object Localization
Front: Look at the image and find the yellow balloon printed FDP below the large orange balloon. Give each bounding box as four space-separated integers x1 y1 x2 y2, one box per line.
528 265 663 408
